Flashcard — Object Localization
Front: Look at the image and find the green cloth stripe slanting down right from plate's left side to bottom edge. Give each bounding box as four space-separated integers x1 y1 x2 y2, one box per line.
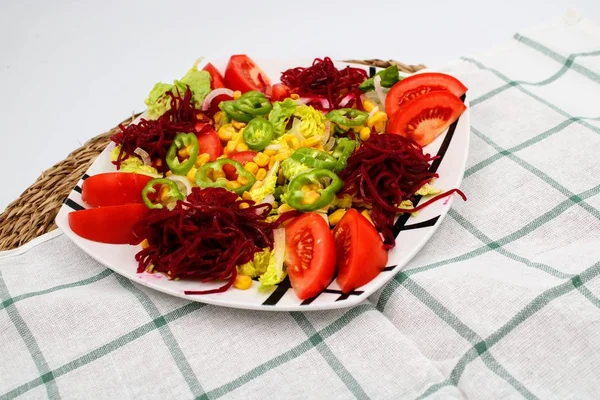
115 275 204 397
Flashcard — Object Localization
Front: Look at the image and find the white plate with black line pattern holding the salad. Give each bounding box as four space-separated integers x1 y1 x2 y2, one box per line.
56 59 470 311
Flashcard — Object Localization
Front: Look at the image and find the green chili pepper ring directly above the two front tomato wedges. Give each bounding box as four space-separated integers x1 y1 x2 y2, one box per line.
288 168 344 211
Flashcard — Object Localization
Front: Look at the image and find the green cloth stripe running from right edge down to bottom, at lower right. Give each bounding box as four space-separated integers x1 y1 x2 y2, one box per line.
419 262 600 398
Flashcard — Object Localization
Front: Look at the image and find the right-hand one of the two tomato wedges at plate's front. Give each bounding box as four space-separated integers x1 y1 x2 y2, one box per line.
333 208 388 293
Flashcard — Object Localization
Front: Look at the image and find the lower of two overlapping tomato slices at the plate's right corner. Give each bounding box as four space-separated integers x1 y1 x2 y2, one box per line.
387 91 467 146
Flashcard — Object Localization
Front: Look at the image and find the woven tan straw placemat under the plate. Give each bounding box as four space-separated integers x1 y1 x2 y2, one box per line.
0 59 425 250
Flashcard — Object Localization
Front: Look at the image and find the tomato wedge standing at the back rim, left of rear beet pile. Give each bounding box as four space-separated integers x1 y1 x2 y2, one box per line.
225 54 271 94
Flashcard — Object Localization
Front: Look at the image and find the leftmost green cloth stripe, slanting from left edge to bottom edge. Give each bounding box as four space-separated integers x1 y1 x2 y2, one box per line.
0 271 60 399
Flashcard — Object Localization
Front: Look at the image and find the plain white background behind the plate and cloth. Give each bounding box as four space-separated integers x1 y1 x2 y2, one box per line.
0 0 600 210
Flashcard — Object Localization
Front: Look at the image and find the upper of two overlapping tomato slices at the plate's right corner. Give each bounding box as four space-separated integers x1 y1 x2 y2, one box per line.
385 72 467 117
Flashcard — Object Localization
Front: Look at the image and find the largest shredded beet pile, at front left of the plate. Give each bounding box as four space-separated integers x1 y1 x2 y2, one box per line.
132 188 279 294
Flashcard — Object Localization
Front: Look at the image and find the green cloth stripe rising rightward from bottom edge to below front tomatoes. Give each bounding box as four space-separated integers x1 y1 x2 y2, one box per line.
199 303 376 400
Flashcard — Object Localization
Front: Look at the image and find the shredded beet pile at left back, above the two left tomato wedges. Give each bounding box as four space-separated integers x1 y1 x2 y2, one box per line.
110 87 210 172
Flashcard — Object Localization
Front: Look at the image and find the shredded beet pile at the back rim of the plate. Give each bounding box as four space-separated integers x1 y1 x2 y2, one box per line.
281 57 368 110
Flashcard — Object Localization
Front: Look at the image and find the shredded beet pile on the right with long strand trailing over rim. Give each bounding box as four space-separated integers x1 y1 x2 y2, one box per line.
340 133 466 249
